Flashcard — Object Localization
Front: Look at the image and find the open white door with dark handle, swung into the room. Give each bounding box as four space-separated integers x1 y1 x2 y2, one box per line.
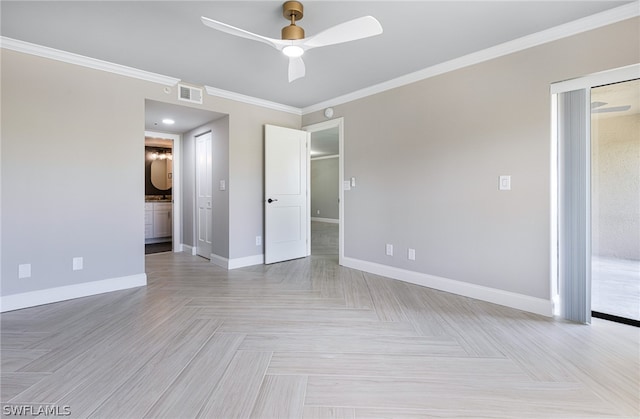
264 125 310 263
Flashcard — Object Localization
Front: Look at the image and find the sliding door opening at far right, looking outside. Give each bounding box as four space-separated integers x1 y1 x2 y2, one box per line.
591 79 640 326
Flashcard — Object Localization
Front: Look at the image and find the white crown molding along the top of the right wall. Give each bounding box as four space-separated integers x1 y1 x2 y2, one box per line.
302 1 640 115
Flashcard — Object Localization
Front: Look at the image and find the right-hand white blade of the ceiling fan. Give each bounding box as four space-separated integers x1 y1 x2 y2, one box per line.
303 16 382 49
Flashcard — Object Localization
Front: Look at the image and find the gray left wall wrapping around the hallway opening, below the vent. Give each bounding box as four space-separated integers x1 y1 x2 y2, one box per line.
1 49 301 296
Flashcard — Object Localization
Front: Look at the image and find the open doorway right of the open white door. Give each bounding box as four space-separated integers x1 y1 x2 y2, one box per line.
303 118 344 264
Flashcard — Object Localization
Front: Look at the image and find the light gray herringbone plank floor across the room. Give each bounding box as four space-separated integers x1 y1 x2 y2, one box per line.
0 228 640 418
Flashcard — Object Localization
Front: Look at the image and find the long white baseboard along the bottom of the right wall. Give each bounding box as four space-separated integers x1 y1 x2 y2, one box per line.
343 257 553 317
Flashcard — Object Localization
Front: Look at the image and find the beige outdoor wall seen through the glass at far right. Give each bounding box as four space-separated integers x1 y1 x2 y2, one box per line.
591 114 640 260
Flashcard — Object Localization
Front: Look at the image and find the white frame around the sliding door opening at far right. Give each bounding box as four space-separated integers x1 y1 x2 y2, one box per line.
550 64 640 322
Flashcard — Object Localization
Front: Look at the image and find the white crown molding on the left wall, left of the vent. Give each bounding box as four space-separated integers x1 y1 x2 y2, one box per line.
0 36 180 86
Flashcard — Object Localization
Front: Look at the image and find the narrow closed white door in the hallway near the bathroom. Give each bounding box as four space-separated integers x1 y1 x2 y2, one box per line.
196 132 213 259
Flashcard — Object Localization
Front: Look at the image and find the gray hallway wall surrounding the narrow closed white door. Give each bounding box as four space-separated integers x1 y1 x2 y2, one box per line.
182 116 229 258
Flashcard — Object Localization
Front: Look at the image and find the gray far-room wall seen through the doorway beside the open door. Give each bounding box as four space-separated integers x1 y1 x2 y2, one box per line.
311 157 340 220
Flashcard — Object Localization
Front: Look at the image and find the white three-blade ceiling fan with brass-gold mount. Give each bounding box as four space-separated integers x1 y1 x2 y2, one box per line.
201 1 382 83
